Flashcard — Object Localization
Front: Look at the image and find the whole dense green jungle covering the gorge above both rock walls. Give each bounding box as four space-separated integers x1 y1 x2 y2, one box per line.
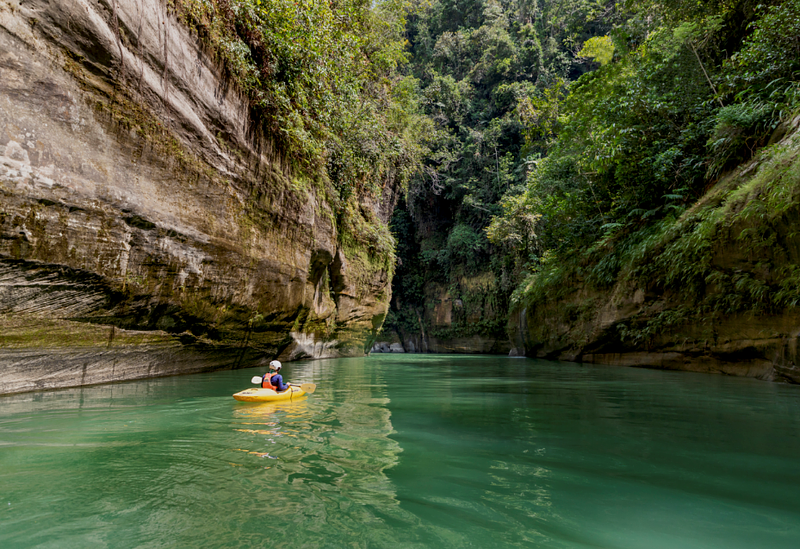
175 0 800 342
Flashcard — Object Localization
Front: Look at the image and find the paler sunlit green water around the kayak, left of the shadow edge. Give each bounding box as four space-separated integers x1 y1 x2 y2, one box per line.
0 361 418 547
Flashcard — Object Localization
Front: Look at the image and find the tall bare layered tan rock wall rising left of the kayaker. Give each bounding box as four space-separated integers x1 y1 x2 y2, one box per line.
0 0 396 393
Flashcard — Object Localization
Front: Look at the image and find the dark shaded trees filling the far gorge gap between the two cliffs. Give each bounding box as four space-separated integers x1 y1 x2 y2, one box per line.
384 0 611 335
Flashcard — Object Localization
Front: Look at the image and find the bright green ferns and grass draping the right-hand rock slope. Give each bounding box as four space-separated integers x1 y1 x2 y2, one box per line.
608 127 800 336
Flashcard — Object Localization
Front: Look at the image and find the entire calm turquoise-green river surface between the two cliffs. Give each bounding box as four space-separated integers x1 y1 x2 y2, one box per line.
0 355 800 549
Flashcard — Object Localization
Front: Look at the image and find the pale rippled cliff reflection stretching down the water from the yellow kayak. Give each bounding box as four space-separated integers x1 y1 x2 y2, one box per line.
222 360 412 547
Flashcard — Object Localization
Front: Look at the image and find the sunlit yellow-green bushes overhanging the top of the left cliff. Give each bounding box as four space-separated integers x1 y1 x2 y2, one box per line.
174 0 425 199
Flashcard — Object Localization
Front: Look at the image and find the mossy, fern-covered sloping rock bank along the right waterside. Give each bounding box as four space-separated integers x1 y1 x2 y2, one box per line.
509 117 800 383
